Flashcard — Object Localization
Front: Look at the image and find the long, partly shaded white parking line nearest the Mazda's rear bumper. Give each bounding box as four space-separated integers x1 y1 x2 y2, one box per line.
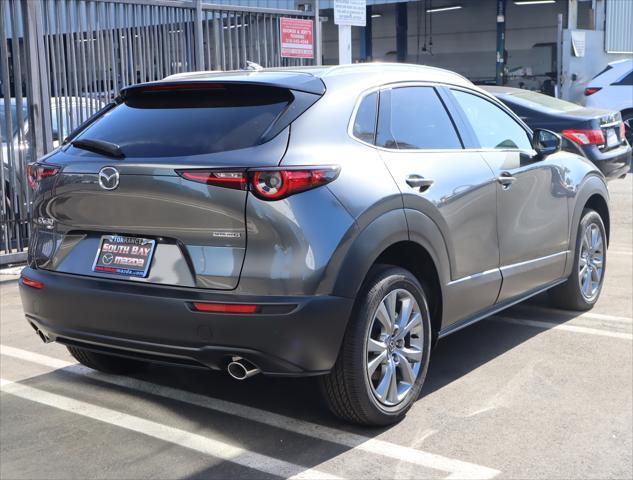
0 345 500 479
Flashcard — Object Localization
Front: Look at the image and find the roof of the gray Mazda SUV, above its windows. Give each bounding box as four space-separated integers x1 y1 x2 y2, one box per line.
161 63 473 93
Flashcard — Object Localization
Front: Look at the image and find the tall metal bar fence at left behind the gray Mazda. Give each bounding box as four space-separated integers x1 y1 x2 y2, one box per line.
0 0 313 264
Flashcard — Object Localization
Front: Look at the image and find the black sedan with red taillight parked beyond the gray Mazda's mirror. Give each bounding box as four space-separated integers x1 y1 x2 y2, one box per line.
484 87 631 179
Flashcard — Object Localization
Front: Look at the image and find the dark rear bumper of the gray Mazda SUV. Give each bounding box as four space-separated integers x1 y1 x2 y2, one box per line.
20 268 353 376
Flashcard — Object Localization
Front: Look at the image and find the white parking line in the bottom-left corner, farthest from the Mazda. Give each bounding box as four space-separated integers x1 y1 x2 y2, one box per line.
0 379 340 479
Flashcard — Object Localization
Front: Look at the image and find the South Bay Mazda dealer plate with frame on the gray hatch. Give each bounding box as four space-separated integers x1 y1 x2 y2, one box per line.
92 235 156 278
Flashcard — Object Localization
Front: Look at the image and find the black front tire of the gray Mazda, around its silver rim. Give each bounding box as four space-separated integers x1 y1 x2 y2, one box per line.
549 208 607 311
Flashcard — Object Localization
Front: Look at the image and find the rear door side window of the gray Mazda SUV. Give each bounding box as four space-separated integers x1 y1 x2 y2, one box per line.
376 87 462 150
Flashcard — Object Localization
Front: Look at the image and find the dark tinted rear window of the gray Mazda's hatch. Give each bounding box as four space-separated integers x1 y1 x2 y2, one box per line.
76 85 292 157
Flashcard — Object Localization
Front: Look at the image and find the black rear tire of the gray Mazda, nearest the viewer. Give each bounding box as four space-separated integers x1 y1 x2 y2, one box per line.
320 265 431 426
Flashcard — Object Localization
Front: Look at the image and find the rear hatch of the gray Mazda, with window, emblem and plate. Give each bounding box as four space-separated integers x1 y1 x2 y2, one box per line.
31 81 319 289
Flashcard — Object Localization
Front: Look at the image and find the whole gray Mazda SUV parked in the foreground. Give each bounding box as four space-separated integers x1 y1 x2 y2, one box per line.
20 64 609 425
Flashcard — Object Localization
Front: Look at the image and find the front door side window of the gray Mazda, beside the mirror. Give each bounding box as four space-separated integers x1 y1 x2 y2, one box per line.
453 90 532 150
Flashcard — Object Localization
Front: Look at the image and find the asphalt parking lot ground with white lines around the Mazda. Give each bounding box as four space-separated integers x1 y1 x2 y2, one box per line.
0 174 633 479
